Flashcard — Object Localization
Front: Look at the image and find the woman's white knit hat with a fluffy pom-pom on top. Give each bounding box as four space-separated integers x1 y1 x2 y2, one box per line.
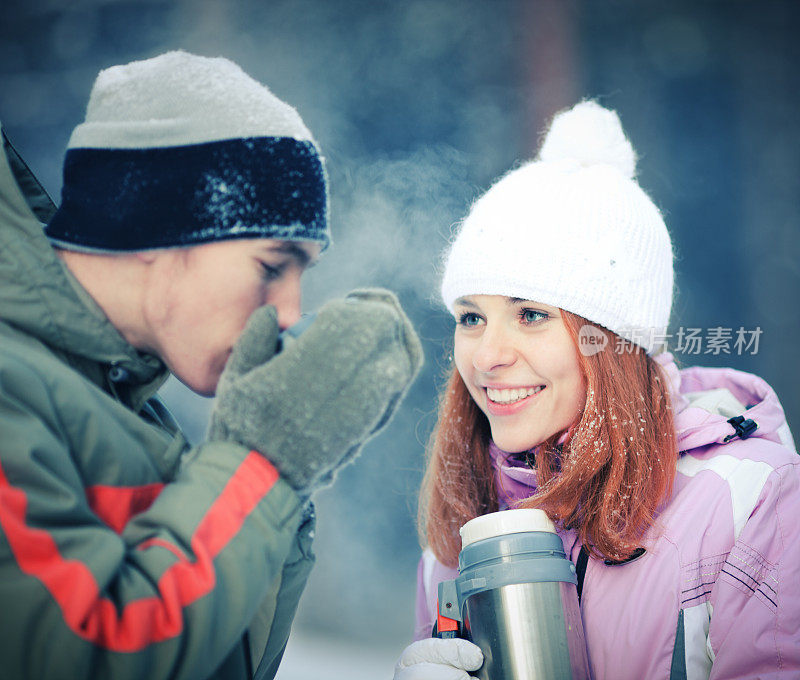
442 101 673 353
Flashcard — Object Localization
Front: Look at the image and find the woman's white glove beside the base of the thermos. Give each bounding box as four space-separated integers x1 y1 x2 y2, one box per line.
394 638 483 680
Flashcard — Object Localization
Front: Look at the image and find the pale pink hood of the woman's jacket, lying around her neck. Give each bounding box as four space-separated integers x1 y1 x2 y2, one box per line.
489 352 795 506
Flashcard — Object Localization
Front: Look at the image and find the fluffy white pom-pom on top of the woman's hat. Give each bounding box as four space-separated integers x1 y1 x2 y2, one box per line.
539 101 636 179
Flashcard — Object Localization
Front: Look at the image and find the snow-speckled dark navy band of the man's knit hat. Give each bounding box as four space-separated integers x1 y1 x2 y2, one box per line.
45 137 330 251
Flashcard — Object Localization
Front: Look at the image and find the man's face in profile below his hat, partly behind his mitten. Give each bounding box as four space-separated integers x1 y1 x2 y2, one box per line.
143 239 320 396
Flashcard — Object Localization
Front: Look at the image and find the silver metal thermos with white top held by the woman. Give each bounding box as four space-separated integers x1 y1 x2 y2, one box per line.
438 509 590 680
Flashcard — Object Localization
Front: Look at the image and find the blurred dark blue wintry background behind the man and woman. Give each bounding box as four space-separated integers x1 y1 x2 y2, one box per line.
0 0 800 680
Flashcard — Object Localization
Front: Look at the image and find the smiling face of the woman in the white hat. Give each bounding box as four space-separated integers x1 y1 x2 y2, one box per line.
454 295 586 453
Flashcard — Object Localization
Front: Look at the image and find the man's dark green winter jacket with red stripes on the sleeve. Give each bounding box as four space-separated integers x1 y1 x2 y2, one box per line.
0 123 314 680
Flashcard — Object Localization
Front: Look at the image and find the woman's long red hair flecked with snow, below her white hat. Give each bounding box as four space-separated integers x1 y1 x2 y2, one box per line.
419 311 678 567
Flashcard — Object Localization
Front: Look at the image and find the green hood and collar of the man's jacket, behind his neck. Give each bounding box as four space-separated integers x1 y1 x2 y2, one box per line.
0 125 168 404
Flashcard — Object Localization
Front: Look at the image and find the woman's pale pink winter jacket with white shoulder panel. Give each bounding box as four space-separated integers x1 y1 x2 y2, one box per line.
415 353 800 680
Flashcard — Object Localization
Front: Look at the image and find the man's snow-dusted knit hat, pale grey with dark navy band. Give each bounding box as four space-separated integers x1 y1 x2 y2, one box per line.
45 51 330 252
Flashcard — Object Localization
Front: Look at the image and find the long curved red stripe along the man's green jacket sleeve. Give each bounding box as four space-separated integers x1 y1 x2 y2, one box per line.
0 451 278 652
